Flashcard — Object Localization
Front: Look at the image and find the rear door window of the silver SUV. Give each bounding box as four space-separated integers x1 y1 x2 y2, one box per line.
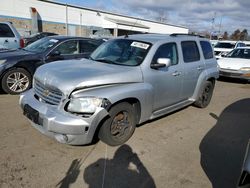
181 41 200 63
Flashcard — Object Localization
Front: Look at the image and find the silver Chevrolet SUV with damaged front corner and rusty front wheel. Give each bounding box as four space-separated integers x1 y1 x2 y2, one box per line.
20 34 219 146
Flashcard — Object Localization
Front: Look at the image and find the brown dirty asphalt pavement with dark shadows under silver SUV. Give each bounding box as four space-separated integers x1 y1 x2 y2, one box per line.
0 80 250 188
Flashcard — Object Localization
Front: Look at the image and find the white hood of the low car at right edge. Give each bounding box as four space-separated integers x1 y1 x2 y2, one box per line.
217 58 250 70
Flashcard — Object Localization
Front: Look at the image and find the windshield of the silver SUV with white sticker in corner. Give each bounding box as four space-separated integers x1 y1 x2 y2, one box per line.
90 39 151 66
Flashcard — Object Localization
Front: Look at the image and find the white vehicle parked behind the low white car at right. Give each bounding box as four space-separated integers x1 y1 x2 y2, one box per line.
214 41 246 59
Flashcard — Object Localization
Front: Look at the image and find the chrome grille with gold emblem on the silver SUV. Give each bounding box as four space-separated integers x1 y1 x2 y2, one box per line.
33 80 62 105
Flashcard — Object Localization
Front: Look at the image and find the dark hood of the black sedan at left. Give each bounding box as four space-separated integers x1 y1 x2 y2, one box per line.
0 49 34 59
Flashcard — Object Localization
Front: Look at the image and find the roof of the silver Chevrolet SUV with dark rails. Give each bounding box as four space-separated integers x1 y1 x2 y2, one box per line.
119 33 207 43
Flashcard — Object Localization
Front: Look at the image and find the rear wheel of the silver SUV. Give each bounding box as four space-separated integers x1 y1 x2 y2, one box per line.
194 81 214 108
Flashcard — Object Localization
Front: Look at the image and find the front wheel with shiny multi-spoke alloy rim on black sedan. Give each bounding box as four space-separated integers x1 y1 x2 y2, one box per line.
2 68 31 95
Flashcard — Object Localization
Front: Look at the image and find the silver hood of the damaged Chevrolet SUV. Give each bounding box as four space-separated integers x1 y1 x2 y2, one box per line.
34 59 143 95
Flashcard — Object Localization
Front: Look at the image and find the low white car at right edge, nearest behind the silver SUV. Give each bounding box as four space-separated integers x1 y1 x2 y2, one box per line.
217 47 250 81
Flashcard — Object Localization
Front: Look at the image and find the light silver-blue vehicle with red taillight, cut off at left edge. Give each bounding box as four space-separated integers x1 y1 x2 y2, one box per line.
0 22 24 51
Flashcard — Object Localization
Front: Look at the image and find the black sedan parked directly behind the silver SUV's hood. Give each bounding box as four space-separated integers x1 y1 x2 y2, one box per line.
0 36 104 94
